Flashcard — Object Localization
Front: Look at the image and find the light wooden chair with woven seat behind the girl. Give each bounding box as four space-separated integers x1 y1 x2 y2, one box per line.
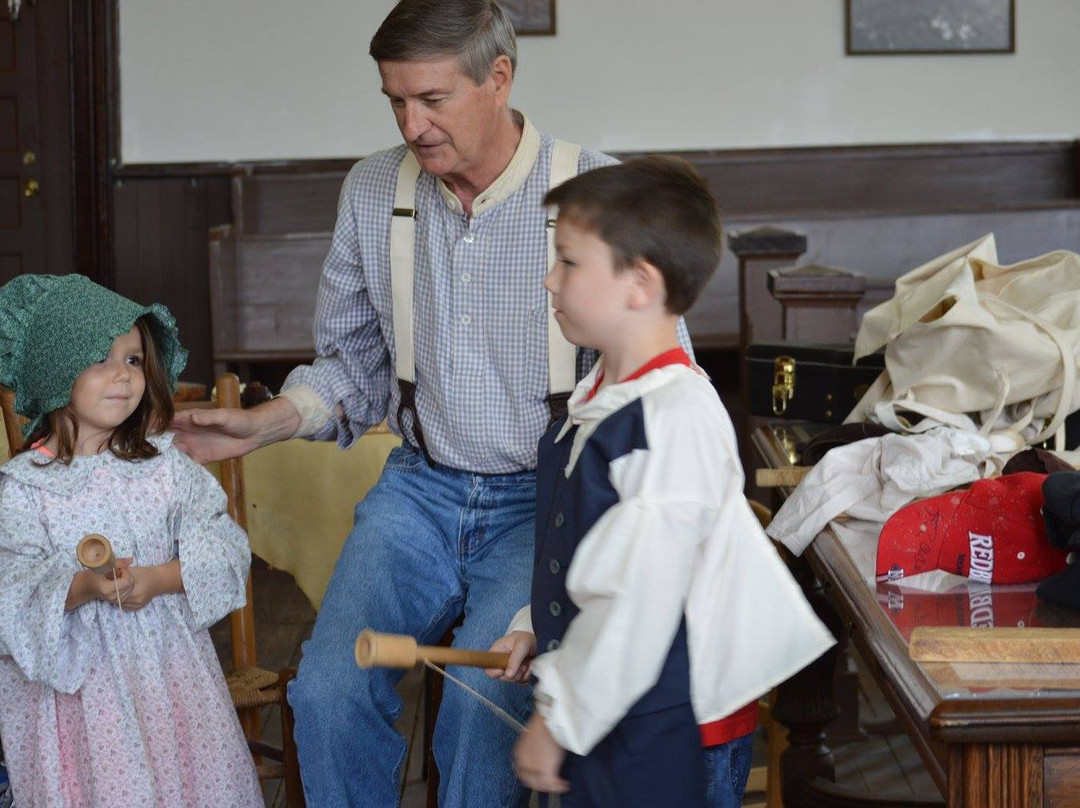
0 374 305 808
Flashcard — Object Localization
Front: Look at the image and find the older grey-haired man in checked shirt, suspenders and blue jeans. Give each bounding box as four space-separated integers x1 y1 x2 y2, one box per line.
177 0 685 808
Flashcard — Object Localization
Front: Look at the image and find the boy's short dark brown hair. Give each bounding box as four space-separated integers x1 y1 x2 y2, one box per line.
543 157 724 314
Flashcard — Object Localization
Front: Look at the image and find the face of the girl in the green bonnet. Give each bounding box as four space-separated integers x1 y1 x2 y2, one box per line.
70 327 146 454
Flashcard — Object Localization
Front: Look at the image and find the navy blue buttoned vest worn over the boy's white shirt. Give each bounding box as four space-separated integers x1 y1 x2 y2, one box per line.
531 400 690 715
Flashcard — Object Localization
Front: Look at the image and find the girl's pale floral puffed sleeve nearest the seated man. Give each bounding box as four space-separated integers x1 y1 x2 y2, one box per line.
171 448 252 631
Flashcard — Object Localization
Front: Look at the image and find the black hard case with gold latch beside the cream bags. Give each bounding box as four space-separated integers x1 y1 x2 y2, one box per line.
746 340 885 423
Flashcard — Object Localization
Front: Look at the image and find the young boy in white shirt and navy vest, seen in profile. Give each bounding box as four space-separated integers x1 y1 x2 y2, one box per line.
489 158 833 808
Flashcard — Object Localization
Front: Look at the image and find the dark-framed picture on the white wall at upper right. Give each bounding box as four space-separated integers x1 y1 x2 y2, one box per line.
845 0 1016 56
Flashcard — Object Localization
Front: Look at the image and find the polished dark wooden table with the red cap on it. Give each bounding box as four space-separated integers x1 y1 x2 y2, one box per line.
753 425 1080 808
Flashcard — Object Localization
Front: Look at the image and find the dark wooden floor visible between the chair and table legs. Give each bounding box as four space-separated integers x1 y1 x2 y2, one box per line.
212 560 936 808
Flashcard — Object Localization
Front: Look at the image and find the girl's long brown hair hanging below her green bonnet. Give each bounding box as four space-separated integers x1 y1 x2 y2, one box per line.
21 315 174 464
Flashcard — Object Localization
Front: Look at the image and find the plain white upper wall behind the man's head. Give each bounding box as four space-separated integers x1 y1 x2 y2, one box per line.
120 0 1080 163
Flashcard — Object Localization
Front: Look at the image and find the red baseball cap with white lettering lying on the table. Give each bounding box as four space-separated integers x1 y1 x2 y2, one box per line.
877 471 1067 583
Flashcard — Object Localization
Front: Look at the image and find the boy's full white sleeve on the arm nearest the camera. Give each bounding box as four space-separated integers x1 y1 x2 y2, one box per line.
532 486 712 755
